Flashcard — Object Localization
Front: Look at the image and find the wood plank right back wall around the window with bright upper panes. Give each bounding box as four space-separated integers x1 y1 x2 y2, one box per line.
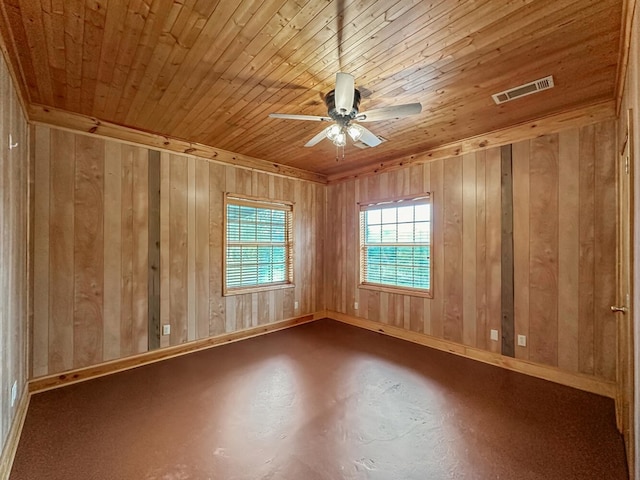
325 121 616 380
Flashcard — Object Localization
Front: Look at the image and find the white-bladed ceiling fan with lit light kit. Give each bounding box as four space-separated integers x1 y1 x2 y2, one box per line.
269 72 422 147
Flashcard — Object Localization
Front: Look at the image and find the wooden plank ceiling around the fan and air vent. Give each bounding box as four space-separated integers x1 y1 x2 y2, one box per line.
0 0 622 175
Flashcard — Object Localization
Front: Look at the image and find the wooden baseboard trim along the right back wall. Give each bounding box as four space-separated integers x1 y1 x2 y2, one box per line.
327 310 616 399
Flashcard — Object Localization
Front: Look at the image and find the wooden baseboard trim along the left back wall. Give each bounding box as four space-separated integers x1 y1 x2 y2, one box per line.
29 311 326 393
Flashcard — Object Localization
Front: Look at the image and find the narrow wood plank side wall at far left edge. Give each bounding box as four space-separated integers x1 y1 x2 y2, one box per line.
0 52 29 458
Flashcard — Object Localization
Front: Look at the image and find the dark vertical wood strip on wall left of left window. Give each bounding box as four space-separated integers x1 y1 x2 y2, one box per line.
147 150 160 350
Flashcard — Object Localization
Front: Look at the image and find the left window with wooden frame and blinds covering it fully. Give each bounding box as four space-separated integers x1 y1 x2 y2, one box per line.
224 194 293 295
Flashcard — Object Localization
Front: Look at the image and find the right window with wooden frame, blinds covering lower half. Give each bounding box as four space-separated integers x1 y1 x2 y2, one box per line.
360 193 431 296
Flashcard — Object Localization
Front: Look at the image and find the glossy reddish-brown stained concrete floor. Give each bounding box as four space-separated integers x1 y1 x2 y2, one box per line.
10 320 627 480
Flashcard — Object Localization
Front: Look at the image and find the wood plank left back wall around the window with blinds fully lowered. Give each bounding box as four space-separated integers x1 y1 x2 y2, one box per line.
32 126 325 377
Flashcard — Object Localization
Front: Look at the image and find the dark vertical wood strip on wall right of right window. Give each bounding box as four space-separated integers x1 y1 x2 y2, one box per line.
500 145 515 357
